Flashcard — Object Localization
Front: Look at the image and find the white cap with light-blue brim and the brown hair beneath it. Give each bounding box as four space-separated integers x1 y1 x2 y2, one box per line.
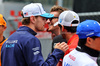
21 3 54 25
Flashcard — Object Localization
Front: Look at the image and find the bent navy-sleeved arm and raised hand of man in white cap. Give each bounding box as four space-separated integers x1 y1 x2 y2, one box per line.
24 39 68 66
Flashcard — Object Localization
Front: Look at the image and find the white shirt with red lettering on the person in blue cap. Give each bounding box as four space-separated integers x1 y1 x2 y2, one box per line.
63 49 97 66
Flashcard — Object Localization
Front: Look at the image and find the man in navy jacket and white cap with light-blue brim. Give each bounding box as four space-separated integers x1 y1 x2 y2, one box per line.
1 3 68 66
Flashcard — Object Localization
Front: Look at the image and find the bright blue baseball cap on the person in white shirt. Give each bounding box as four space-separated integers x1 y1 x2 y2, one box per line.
76 20 100 39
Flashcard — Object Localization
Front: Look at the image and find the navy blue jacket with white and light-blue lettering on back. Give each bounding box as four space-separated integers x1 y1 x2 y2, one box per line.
1 26 64 66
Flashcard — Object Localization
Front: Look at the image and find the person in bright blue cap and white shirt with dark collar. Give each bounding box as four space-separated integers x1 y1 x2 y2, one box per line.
63 20 100 66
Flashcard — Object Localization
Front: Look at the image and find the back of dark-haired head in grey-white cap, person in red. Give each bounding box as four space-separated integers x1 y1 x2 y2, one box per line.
58 10 80 33
